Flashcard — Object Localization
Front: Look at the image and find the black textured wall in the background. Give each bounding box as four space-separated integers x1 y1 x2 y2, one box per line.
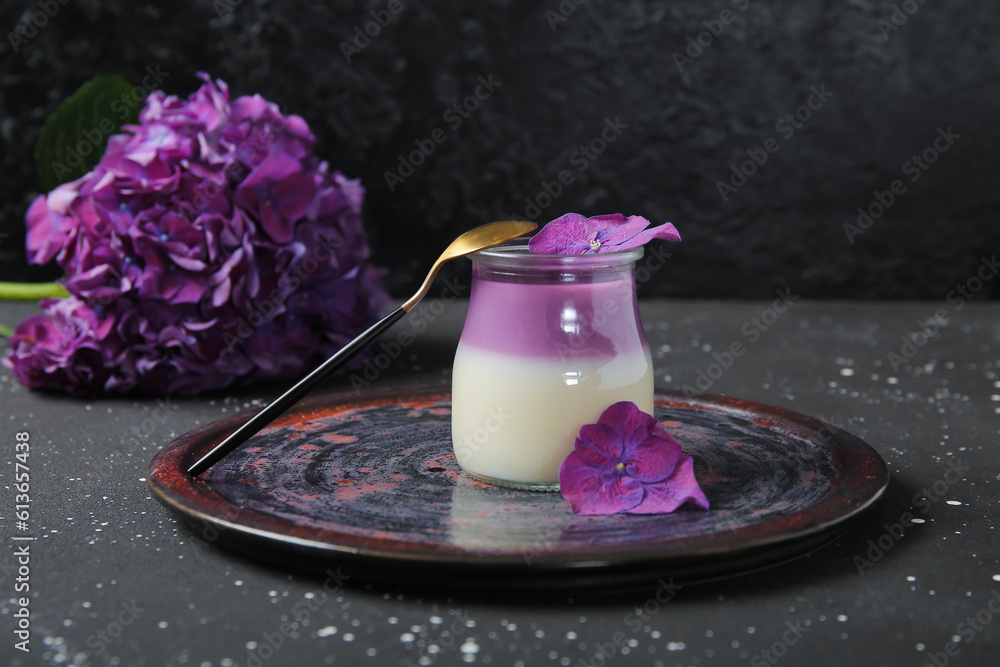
0 0 1000 299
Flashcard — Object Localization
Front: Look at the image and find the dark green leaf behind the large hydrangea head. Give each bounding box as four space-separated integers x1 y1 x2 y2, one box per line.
35 74 141 192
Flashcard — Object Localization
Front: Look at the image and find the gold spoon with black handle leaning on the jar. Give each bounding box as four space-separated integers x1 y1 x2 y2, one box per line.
188 220 537 477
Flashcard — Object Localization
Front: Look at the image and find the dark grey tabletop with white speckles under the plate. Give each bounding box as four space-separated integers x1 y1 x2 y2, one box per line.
0 301 1000 667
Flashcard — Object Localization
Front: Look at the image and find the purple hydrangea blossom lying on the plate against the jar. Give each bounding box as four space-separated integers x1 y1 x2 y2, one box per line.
559 401 708 515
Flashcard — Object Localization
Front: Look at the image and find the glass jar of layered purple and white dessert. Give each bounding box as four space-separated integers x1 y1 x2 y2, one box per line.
452 240 653 491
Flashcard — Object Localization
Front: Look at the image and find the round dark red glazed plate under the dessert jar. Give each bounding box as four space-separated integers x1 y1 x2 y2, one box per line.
148 387 889 590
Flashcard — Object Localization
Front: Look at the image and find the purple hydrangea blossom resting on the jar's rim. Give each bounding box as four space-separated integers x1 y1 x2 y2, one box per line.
528 213 681 255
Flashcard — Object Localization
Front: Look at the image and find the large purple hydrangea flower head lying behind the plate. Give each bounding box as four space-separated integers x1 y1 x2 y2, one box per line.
3 74 388 394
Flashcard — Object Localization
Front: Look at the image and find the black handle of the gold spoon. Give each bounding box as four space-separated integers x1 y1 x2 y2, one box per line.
188 308 406 477
